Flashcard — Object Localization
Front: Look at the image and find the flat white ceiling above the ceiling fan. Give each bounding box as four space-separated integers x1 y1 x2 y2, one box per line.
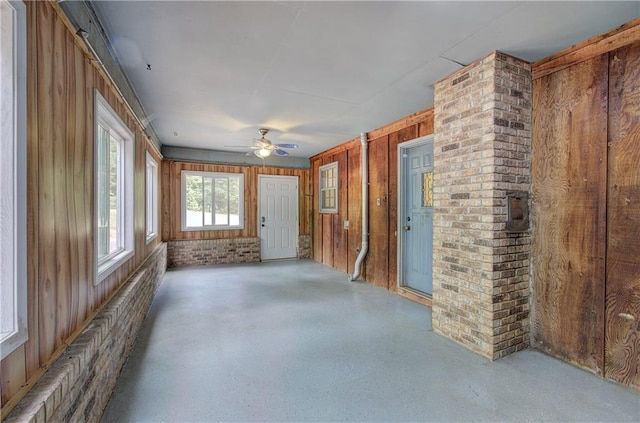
92 0 640 157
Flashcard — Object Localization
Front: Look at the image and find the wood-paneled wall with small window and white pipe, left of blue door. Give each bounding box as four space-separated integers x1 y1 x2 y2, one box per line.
311 108 433 290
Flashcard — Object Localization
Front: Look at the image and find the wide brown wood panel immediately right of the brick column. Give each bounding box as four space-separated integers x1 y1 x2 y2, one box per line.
532 55 608 374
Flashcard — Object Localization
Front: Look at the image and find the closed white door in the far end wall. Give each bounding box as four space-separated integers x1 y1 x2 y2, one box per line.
258 175 298 260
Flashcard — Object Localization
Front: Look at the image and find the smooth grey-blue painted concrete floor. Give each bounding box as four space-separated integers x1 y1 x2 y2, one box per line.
103 260 640 422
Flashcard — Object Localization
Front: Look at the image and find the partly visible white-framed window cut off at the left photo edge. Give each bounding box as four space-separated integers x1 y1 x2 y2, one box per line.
0 0 28 358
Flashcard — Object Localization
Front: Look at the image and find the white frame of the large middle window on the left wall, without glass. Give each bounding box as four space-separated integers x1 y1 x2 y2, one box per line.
94 89 135 285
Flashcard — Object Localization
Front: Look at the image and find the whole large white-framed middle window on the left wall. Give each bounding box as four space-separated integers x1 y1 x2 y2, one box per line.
95 90 134 283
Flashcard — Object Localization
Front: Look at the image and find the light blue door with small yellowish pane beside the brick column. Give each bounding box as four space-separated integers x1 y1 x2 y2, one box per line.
400 141 433 296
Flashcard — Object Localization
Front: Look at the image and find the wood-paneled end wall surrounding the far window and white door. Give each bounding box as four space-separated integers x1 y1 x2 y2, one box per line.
162 160 311 241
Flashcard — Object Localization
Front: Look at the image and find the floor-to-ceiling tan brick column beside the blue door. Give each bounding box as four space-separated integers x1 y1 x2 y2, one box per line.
433 52 532 360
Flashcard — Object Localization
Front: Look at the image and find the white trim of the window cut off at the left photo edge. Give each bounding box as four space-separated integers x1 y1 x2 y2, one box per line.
0 0 29 359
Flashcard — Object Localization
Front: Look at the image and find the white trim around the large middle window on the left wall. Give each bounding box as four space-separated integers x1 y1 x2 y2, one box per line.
93 89 135 285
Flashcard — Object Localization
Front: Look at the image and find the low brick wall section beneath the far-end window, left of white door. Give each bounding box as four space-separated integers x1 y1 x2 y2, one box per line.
167 238 260 267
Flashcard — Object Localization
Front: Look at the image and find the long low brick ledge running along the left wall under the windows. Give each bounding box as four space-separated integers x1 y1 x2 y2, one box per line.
5 244 167 423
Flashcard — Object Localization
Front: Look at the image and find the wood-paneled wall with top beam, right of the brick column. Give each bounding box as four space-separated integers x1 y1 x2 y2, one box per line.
532 19 640 389
